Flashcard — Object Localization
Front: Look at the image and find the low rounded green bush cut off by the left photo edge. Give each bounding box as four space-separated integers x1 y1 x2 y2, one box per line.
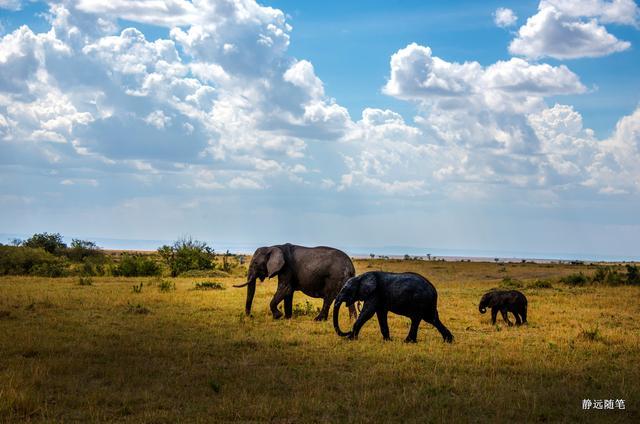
0 246 68 277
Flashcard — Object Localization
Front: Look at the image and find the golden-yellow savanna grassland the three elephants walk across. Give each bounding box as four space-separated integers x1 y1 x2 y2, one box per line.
0 260 640 423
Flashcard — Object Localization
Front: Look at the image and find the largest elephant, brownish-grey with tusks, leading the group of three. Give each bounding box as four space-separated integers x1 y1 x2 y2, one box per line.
234 243 355 321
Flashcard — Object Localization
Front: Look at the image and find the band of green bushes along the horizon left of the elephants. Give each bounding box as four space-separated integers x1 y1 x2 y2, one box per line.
0 233 244 277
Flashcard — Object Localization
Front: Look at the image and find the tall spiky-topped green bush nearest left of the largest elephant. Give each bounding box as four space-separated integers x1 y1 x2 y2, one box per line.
158 237 215 277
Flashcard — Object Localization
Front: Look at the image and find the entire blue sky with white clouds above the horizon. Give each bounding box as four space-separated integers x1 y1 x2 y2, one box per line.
0 0 640 258
